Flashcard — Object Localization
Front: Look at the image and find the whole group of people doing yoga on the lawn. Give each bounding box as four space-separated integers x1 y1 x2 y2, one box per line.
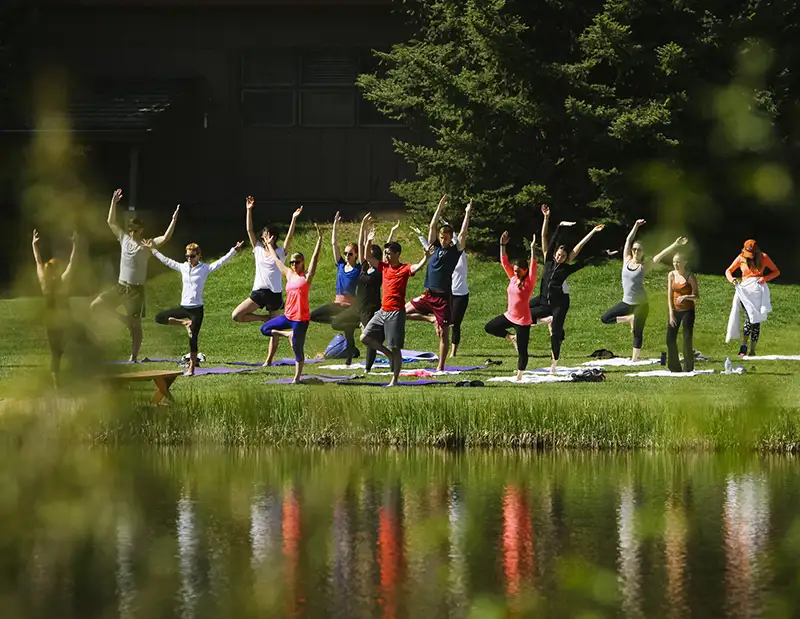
32 189 780 386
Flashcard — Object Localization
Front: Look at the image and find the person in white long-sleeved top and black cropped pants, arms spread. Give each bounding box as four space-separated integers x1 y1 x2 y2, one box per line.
142 241 244 376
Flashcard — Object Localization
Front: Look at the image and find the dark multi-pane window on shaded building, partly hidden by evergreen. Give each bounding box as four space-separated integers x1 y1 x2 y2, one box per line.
241 48 400 127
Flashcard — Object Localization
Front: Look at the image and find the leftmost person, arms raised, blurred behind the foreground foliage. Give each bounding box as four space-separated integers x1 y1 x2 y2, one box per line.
31 230 78 389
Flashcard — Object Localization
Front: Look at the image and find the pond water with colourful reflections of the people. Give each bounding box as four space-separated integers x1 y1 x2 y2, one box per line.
0 447 800 619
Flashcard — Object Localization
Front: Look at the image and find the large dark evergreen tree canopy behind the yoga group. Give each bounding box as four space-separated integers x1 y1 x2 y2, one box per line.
359 0 798 264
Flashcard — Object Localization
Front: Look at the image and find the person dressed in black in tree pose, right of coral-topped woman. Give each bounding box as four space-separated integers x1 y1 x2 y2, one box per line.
530 204 603 374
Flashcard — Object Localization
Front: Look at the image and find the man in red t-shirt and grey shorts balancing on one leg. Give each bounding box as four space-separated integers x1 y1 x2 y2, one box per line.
361 241 428 387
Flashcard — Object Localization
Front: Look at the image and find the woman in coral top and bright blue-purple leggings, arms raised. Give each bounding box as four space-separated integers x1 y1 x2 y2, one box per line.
261 224 322 384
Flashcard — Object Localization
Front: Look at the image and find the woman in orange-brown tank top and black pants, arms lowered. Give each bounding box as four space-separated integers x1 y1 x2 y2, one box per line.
667 254 700 372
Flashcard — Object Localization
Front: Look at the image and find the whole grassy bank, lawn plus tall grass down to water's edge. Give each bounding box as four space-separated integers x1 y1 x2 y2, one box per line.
0 226 800 450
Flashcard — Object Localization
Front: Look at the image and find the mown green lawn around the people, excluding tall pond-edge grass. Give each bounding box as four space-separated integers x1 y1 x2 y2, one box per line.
0 224 800 446
